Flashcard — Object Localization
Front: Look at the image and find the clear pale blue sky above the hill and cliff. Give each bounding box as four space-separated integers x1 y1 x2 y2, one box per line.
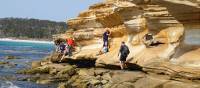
0 0 102 22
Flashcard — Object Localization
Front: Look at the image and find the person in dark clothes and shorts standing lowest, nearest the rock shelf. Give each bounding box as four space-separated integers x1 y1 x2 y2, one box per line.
118 42 130 69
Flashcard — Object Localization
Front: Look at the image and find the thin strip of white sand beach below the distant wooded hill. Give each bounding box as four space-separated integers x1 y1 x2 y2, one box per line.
0 38 53 44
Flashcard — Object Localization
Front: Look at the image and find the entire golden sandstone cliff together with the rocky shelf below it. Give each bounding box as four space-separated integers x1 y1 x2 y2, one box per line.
15 0 200 88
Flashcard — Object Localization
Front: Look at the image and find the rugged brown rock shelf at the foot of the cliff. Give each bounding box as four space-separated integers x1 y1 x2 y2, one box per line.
18 53 200 88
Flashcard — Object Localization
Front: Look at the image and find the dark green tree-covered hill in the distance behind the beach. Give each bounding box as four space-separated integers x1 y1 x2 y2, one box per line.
0 18 67 40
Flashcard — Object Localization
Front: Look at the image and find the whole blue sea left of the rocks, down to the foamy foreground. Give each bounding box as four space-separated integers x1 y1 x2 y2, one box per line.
0 40 55 88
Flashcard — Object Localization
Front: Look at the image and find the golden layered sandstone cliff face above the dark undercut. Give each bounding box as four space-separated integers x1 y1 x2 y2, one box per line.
53 0 200 78
